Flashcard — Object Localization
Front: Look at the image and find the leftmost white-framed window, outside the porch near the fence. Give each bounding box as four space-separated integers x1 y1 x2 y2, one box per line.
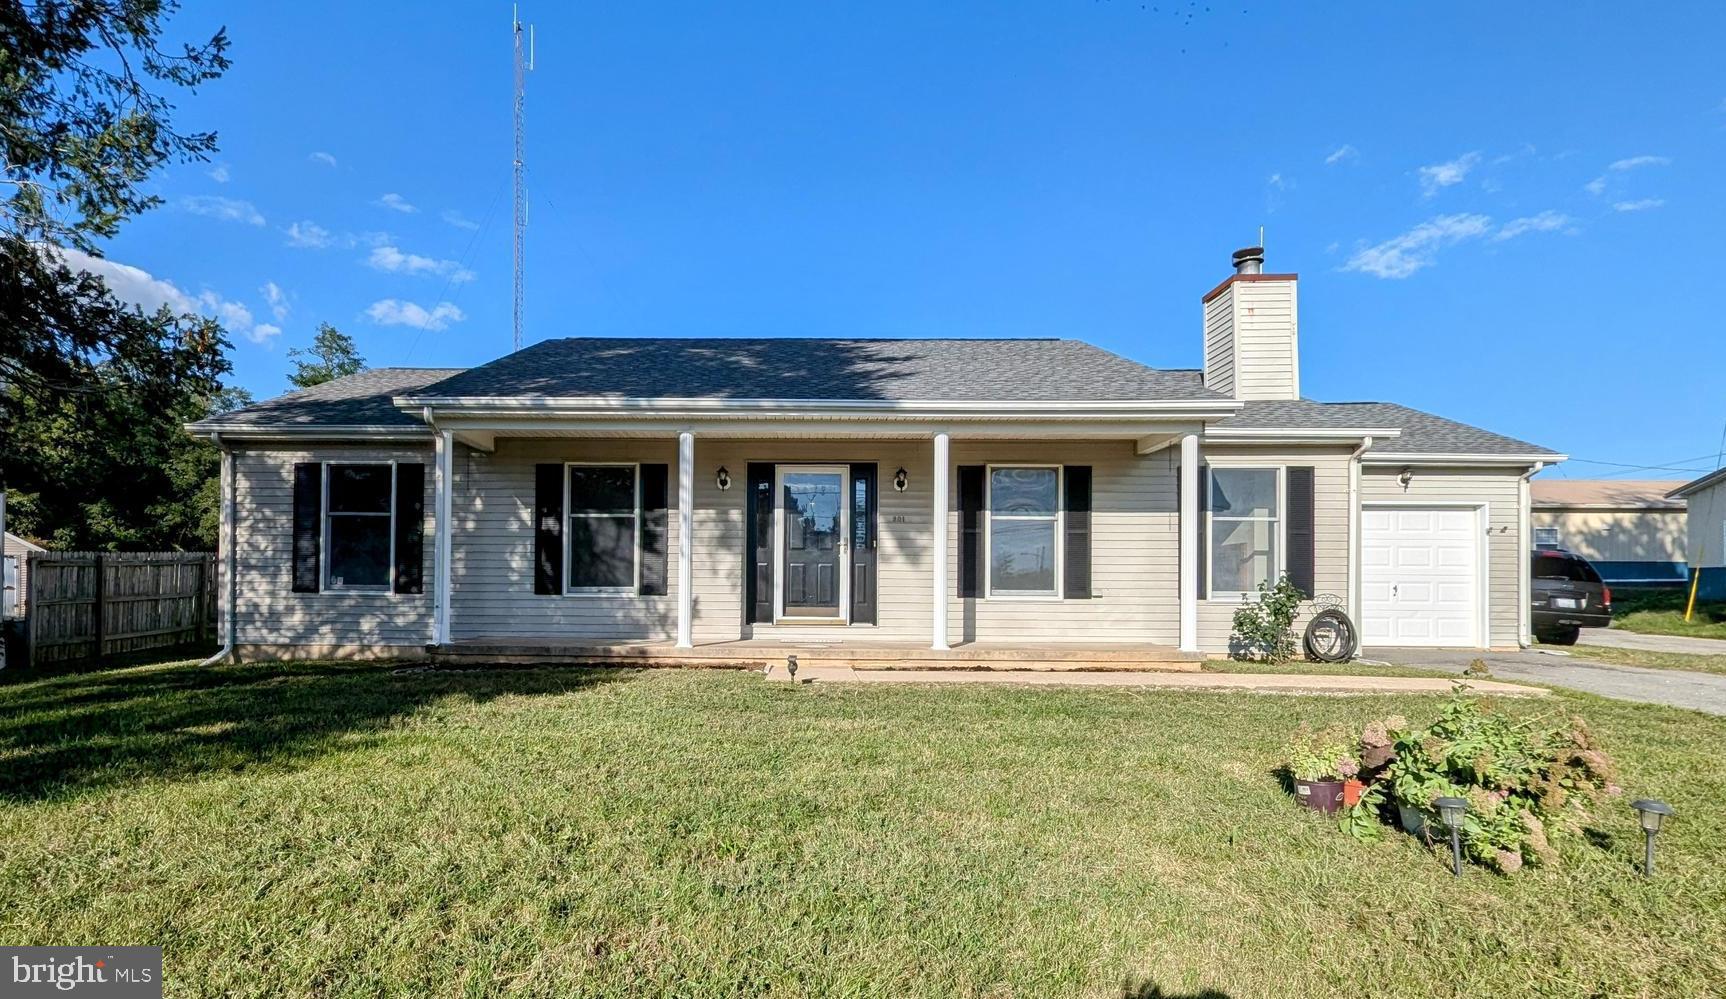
323 461 395 594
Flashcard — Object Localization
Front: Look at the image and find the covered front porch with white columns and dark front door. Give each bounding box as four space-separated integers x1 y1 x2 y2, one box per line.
399 400 1210 668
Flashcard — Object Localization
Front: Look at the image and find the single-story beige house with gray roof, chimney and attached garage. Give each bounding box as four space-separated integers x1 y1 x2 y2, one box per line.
192 250 1564 657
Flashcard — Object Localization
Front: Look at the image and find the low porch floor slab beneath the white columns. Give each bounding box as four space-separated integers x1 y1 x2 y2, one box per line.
430 637 1205 673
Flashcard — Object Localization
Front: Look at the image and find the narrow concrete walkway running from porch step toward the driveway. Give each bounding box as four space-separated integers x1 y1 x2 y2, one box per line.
766 666 1548 697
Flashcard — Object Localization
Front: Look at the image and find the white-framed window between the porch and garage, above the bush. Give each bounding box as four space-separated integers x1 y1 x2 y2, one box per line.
1205 468 1282 597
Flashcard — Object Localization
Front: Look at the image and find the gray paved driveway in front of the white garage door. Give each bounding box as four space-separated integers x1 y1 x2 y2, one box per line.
1367 638 1726 714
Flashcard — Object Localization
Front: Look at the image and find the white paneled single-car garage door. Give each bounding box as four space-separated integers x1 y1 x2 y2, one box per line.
1360 507 1481 649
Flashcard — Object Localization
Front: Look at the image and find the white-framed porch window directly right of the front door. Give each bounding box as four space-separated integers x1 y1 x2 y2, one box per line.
984 464 1063 599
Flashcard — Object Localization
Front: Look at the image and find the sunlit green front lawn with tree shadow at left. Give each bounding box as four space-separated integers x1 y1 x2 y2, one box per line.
0 664 1726 999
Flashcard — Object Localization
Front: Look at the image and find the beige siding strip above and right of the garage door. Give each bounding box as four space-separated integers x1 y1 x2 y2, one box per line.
1360 464 1533 647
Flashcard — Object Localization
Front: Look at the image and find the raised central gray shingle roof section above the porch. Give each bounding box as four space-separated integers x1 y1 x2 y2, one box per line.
405 338 1224 402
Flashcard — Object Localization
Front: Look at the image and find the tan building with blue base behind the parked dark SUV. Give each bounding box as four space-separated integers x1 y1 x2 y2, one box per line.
1529 478 1690 587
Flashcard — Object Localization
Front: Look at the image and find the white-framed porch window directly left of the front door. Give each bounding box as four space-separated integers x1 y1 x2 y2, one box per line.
563 462 642 594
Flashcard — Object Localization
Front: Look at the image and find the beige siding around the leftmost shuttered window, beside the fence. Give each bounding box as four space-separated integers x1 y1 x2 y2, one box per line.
233 443 435 656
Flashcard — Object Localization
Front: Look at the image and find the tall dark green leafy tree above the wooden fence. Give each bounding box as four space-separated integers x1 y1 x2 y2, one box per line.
0 0 230 547
